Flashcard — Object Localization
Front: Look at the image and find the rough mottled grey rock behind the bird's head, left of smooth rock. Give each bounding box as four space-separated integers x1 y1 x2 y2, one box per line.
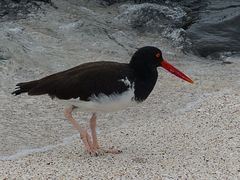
115 3 187 41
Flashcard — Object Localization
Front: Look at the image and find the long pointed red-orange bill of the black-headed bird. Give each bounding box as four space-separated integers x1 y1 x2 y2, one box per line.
161 60 193 84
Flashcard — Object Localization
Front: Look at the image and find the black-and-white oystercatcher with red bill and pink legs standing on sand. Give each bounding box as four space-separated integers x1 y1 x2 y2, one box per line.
12 46 193 156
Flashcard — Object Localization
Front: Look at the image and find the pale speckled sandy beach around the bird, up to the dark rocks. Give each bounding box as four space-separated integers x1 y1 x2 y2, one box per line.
0 1 240 180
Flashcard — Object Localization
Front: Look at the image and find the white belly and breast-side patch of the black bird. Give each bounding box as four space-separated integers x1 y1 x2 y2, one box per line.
58 78 136 112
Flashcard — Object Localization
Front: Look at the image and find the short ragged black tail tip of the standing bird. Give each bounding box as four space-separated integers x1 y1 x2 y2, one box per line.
12 80 38 96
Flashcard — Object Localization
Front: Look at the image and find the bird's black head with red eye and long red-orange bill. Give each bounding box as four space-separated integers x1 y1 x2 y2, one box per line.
129 46 193 83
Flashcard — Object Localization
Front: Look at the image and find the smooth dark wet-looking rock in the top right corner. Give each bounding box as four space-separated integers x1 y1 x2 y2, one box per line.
185 0 240 59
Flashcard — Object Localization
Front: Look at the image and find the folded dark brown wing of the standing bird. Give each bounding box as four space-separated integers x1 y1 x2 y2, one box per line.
23 61 134 101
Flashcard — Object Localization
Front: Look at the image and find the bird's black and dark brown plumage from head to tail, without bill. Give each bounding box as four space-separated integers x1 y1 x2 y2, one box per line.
12 47 159 101
